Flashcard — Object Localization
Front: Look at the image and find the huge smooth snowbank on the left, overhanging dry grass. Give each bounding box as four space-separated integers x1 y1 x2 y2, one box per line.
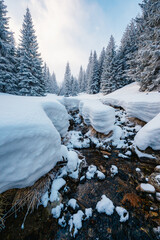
0 94 68 193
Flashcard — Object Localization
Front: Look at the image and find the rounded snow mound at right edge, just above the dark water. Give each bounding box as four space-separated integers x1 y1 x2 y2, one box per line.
134 113 160 150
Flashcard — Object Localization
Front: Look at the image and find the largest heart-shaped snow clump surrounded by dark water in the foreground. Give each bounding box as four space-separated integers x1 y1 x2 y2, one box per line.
96 195 114 215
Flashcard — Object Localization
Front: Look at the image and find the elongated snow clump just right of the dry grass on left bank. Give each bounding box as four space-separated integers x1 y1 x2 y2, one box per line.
50 178 66 202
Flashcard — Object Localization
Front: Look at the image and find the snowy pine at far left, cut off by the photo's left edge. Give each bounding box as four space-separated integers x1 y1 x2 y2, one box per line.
0 0 17 94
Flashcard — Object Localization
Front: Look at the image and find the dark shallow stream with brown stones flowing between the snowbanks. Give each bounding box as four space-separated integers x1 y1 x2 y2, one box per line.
0 108 160 240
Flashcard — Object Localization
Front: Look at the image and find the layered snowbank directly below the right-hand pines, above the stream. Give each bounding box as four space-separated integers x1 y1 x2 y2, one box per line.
101 83 160 122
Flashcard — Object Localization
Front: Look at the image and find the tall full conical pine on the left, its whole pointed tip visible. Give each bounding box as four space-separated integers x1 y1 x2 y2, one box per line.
18 8 45 96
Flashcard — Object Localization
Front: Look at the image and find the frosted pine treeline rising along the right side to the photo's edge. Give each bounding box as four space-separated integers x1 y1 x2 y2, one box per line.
62 0 160 96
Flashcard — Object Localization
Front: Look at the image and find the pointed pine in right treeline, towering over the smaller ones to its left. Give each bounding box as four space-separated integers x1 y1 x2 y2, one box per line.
101 36 116 94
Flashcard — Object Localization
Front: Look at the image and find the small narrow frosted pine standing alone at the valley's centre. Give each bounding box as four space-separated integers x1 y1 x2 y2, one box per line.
64 63 72 97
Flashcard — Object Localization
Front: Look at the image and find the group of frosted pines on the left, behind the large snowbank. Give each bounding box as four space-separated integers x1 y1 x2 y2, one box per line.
0 0 59 96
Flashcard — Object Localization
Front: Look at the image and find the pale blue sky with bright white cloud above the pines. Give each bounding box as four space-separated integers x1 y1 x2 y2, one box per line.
4 0 142 83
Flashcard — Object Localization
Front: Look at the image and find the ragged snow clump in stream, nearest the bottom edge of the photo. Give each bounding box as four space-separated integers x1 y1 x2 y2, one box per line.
68 210 84 237
